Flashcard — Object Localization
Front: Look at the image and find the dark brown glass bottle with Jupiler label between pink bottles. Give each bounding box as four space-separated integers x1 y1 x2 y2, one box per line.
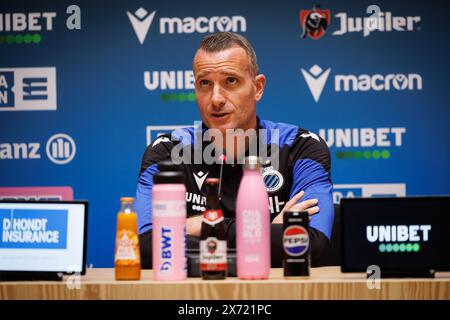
200 178 227 280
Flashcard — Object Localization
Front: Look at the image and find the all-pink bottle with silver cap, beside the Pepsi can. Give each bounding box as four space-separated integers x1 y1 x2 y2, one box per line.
236 156 270 279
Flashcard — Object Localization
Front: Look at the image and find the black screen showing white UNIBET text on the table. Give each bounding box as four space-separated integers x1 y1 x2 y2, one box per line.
341 196 450 272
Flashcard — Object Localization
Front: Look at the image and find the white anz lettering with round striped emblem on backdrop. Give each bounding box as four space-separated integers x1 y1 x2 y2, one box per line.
0 133 76 164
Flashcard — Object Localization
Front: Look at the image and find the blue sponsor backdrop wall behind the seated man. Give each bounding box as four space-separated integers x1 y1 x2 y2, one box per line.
0 0 450 267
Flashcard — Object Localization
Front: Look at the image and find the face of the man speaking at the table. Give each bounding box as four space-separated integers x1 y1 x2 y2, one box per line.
194 47 265 133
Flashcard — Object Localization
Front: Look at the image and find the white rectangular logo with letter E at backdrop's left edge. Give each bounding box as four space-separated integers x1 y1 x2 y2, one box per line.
0 67 56 111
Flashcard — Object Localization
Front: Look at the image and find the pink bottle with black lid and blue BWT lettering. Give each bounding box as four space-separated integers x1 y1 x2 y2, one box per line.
152 162 187 281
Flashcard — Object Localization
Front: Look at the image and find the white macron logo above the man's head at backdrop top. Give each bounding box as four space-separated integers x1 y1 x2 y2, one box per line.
127 7 247 44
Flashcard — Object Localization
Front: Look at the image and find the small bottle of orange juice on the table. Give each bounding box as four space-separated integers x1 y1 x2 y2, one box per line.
114 197 141 280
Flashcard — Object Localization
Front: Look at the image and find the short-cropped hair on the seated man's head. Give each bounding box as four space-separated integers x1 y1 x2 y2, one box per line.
198 32 259 76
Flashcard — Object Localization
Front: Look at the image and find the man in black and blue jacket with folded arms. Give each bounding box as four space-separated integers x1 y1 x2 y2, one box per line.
135 32 334 268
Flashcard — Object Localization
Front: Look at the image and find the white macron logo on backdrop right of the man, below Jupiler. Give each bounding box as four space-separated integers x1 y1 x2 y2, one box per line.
301 64 423 102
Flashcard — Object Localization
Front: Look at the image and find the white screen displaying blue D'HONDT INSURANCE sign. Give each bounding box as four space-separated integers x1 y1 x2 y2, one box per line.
0 200 87 274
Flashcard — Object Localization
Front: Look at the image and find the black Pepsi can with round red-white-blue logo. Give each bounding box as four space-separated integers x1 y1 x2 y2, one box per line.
282 210 310 277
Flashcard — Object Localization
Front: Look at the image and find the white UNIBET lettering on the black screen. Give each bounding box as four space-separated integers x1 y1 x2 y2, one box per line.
366 224 431 242
